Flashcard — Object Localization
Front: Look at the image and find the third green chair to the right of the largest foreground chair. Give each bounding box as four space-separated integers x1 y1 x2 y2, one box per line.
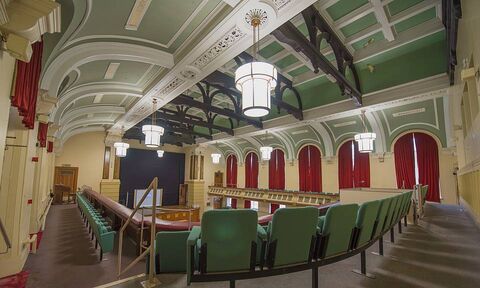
355 200 380 247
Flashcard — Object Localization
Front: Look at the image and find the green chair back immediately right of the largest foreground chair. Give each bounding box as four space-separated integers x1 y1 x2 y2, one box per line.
266 207 318 268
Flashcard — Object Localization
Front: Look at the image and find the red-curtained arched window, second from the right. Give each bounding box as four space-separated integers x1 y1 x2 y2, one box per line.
338 140 370 189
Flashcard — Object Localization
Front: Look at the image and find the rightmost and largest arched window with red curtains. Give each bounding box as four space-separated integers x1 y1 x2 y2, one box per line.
393 132 440 202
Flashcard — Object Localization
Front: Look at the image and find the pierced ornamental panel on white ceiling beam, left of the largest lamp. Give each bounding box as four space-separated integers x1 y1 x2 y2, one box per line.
193 26 246 69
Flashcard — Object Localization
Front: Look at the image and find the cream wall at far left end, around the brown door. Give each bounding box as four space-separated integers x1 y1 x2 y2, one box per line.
55 132 105 191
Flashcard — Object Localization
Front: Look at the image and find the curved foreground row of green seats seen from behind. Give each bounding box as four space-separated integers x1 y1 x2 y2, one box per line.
147 191 412 287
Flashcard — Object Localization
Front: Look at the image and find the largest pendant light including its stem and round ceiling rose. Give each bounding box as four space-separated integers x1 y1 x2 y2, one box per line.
235 9 277 117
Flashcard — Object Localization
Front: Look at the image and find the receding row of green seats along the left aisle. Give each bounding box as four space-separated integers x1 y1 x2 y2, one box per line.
77 193 116 260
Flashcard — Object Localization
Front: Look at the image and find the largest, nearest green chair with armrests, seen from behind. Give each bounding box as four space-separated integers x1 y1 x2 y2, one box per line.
187 209 266 284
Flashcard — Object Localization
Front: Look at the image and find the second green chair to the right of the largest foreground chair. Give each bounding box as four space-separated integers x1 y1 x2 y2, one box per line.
317 204 358 258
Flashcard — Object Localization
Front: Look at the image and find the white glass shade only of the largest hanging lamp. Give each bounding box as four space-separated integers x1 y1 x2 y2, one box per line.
235 62 277 117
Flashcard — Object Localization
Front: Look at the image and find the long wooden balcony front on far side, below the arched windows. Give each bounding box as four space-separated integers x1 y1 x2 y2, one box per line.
208 186 339 206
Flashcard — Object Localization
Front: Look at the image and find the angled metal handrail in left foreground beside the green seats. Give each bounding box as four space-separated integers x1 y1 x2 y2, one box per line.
118 177 158 287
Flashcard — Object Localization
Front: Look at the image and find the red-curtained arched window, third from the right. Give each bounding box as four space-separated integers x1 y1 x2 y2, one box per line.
298 145 322 192
